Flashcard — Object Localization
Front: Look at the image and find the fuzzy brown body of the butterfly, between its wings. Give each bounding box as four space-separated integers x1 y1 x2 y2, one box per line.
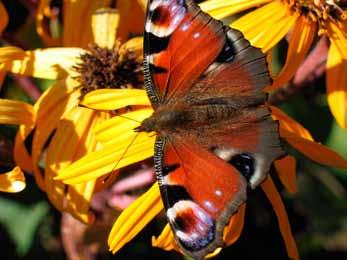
136 104 238 133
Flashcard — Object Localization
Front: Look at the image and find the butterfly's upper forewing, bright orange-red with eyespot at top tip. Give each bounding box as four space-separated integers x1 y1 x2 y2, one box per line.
144 0 225 107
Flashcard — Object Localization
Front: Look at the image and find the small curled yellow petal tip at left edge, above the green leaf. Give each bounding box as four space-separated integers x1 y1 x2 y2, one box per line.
0 167 25 192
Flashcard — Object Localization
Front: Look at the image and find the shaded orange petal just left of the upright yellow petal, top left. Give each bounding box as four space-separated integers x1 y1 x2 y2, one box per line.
63 0 112 48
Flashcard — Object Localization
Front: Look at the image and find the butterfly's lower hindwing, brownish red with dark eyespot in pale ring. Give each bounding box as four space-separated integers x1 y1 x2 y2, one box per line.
193 106 284 189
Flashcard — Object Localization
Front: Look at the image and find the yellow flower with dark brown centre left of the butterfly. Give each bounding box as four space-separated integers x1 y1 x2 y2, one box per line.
0 1 147 223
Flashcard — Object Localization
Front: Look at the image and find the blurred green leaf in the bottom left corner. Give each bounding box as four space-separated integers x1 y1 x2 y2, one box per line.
0 197 49 256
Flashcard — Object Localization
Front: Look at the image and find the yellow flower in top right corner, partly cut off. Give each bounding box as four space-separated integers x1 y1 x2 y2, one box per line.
201 0 347 128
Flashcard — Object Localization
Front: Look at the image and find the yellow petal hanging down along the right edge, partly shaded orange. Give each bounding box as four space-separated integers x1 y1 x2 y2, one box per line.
326 23 347 129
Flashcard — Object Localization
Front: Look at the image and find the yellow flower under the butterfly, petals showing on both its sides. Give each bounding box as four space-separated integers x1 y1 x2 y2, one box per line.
56 86 347 259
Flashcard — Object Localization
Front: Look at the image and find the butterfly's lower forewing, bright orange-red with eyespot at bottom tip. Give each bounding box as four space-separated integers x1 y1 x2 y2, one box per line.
155 136 247 259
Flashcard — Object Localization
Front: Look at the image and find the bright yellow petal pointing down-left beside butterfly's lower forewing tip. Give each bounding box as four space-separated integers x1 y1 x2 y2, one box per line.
108 183 164 253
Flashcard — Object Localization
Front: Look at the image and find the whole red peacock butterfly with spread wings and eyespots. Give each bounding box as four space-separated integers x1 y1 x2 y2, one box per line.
136 0 283 259
